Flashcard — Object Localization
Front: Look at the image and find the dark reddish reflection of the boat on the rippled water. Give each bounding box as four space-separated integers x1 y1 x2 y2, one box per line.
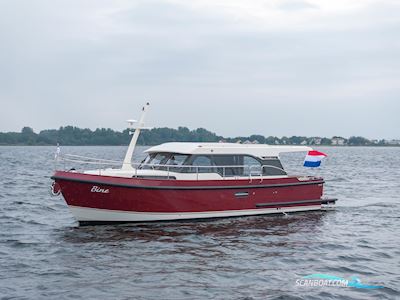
61 211 326 244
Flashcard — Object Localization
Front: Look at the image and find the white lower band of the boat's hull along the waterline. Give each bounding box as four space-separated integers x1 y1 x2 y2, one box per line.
69 204 321 222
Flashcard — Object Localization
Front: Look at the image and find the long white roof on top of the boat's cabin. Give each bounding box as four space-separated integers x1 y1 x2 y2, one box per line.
145 142 313 157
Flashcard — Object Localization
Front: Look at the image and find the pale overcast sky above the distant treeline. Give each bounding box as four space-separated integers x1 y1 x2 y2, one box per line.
0 0 400 139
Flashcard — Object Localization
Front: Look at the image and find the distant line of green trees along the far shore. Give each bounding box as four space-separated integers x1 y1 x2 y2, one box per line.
0 126 394 146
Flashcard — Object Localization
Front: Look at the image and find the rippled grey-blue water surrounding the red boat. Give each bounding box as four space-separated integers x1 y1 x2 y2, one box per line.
0 147 400 299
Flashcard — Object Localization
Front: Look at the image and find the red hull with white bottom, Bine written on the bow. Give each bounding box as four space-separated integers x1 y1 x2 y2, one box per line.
52 171 324 222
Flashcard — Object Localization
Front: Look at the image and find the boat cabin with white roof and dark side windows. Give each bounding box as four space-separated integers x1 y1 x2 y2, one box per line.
137 143 310 178
